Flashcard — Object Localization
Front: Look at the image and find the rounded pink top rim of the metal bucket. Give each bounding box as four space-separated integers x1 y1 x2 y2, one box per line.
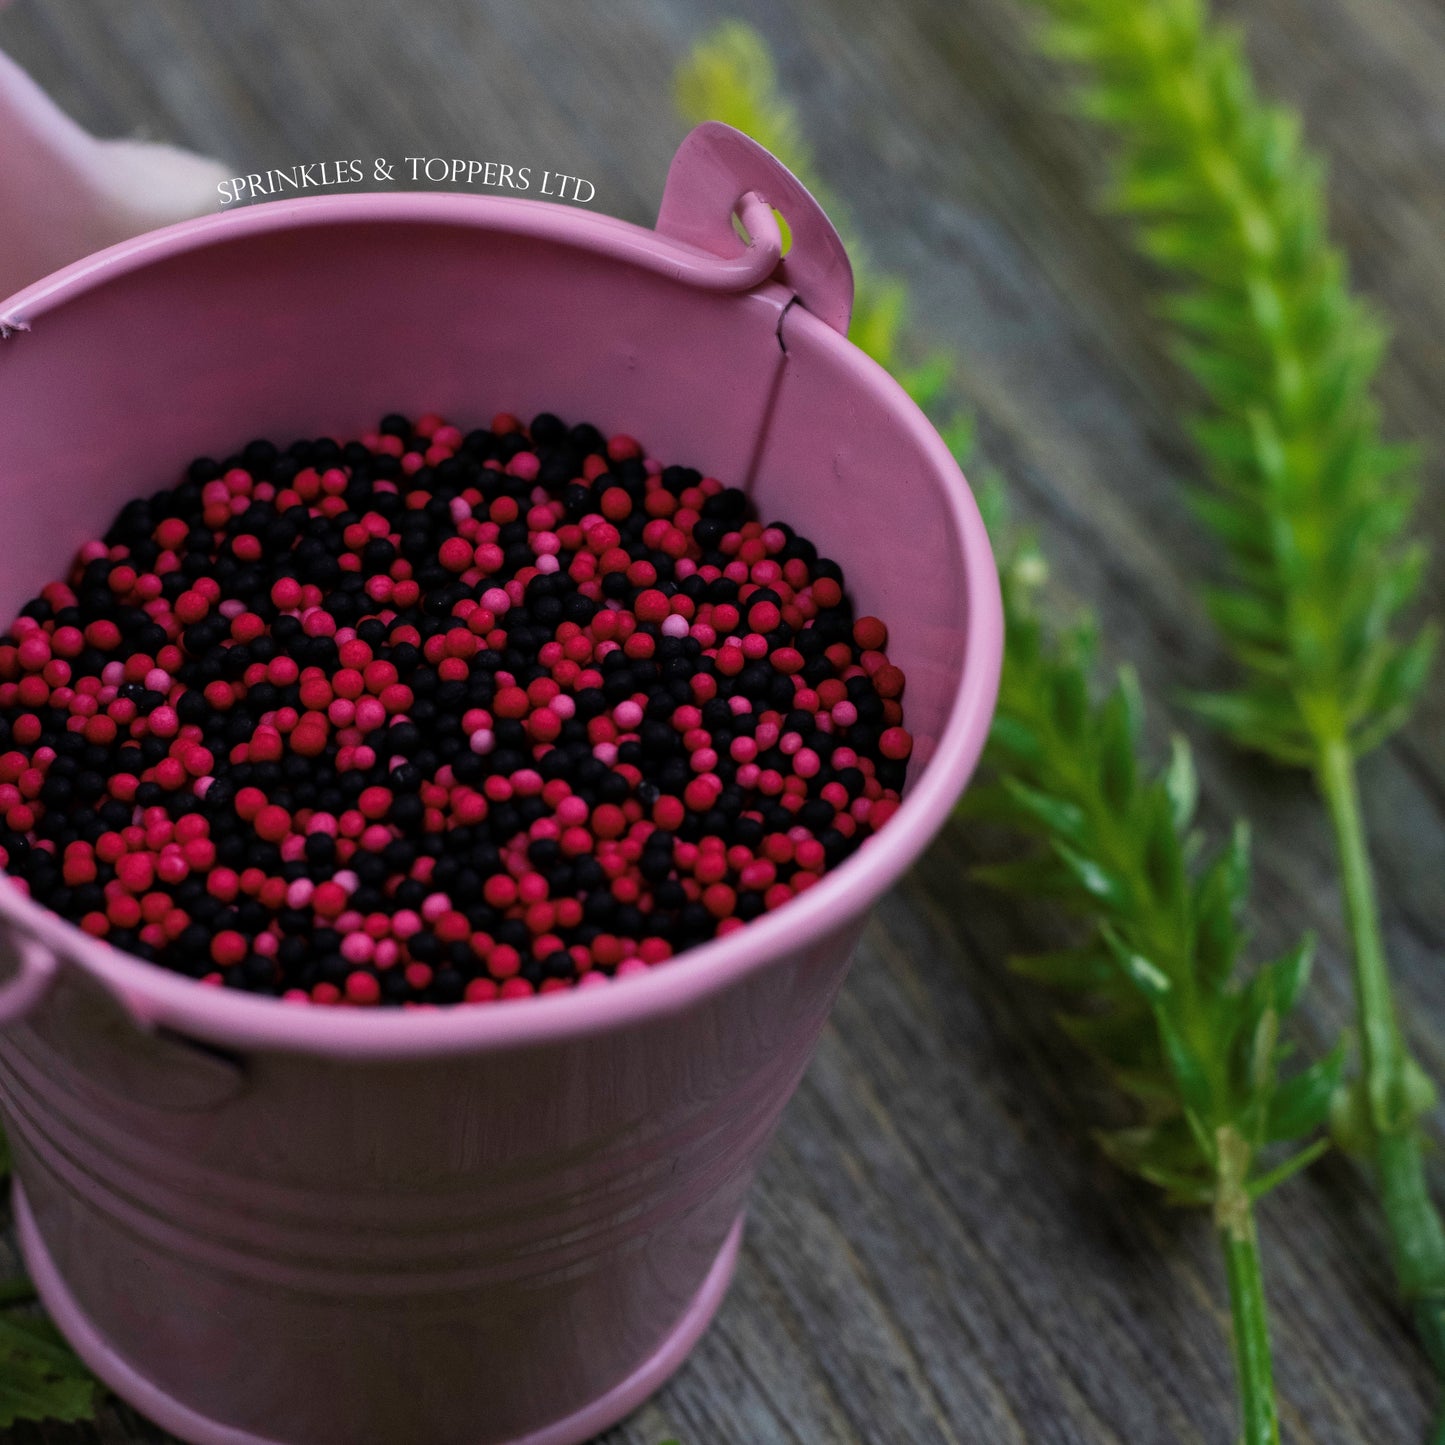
0 192 1003 1061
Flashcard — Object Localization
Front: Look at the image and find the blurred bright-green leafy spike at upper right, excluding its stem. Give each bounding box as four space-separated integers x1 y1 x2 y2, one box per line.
1039 0 1435 766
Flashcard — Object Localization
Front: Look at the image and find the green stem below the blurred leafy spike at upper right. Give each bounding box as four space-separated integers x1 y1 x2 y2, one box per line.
1316 741 1445 1381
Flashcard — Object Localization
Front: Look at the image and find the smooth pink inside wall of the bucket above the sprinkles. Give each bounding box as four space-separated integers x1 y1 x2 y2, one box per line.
0 209 964 779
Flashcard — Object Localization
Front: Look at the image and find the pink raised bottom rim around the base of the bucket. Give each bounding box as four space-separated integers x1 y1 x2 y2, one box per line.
12 1181 743 1445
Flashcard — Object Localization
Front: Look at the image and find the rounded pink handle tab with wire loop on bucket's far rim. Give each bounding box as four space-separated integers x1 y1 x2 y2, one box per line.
656 120 853 335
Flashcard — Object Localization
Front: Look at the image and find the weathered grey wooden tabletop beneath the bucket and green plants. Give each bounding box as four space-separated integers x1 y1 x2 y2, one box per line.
0 0 1445 1445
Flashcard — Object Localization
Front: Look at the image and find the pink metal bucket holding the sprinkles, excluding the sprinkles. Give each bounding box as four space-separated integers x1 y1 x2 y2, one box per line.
0 124 1001 1445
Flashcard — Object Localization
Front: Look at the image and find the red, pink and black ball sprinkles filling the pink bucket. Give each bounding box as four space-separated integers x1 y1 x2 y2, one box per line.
0 413 912 1007
